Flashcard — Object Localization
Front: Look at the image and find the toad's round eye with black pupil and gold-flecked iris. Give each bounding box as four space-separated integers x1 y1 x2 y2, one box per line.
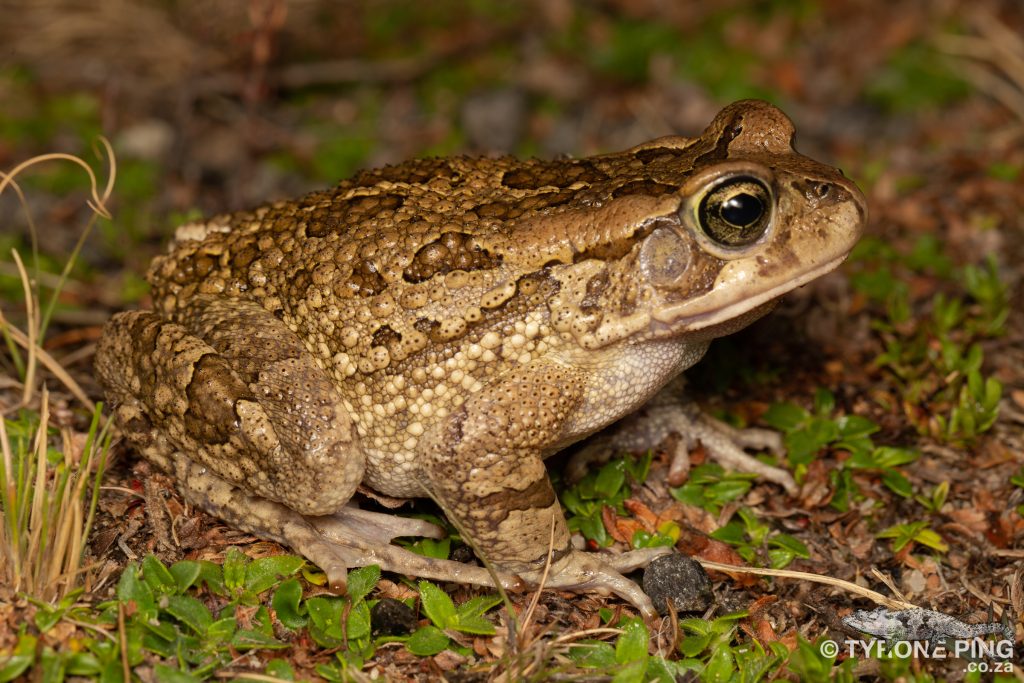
697 176 771 247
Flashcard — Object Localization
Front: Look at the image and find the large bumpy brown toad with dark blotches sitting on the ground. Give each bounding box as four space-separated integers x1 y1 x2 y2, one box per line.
96 100 865 615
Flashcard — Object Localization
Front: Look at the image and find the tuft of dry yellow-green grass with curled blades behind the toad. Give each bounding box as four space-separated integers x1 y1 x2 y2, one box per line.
0 140 116 602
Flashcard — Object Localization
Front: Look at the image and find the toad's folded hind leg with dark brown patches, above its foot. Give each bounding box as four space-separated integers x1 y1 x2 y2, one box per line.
96 297 365 514
